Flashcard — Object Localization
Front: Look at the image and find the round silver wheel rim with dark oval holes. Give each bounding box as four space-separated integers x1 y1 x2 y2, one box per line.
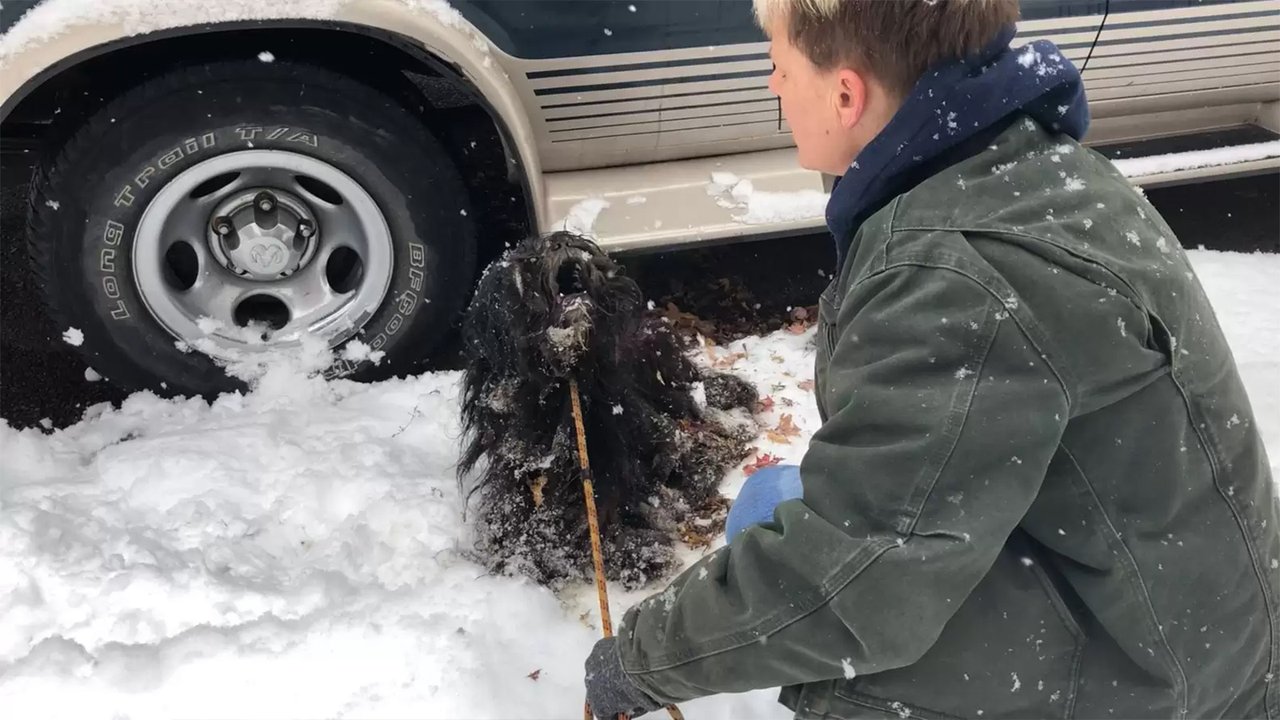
133 150 394 359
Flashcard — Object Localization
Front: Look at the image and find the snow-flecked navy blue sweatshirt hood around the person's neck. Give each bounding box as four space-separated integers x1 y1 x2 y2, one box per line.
827 27 1089 266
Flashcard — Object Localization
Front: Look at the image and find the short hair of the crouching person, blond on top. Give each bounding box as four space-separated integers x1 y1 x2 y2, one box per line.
754 0 1019 96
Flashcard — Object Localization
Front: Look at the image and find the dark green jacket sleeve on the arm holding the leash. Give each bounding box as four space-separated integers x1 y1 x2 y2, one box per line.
618 258 1069 702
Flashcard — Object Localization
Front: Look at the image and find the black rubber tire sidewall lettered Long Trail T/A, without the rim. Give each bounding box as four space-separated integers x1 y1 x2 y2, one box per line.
51 70 475 393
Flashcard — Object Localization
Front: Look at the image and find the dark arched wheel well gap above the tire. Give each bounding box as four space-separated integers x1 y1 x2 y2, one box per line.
0 23 535 263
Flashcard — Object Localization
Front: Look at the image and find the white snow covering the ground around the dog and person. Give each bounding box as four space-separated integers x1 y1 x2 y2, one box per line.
0 251 1280 720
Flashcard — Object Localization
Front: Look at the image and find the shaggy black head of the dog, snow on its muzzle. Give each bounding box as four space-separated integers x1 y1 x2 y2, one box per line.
472 231 641 377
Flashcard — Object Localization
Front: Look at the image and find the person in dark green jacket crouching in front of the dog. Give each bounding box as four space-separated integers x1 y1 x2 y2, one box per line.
586 0 1280 720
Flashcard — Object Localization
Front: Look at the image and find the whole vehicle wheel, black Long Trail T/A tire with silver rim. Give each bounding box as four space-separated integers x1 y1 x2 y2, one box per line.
28 61 476 396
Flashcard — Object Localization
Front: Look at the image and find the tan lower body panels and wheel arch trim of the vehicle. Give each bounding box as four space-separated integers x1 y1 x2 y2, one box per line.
0 0 1280 250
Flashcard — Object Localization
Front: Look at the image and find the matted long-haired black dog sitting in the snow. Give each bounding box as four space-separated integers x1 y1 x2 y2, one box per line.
460 232 758 587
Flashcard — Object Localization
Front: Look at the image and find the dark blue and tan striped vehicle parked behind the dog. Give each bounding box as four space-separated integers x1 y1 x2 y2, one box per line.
0 0 1280 395
